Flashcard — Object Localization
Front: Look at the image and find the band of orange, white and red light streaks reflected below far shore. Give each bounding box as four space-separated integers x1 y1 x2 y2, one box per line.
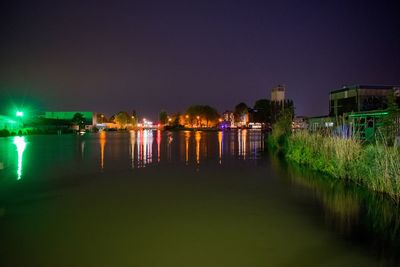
95 129 264 169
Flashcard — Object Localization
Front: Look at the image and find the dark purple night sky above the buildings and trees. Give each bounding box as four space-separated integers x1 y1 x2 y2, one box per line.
0 0 400 119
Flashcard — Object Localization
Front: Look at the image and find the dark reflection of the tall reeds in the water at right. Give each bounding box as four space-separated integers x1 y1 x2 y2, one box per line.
271 157 400 266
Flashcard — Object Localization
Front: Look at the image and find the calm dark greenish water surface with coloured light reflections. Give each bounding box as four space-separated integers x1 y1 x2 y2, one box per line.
0 130 400 267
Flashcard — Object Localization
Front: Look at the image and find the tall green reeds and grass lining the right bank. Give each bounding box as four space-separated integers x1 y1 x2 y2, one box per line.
268 131 400 202
